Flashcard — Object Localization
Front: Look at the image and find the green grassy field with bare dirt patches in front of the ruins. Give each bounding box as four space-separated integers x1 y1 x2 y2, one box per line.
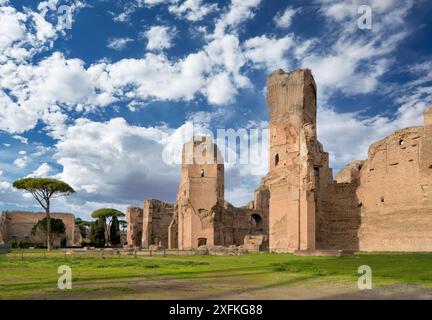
0 250 432 299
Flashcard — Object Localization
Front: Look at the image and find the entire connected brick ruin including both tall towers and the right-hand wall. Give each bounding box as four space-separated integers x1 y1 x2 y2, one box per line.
127 69 432 252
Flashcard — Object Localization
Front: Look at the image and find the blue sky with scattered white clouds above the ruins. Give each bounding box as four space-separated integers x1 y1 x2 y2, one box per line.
0 0 432 217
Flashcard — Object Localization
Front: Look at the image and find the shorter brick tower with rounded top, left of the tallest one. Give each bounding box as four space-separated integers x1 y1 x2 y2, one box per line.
177 137 224 249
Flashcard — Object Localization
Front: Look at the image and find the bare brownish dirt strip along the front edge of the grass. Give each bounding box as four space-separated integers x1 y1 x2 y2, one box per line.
33 277 432 300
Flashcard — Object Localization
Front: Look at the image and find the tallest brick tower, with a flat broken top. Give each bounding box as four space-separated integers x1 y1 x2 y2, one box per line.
264 69 319 252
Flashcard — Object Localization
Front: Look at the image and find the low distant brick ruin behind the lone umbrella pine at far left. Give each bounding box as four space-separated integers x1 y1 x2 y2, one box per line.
0 211 81 246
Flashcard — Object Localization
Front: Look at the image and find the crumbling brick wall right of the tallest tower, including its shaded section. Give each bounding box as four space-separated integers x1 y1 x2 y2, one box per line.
317 109 432 251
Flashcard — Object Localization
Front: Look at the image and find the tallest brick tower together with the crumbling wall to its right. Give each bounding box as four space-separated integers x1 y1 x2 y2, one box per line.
263 70 432 251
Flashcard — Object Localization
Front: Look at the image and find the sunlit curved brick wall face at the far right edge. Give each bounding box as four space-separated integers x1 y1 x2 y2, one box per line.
357 115 432 251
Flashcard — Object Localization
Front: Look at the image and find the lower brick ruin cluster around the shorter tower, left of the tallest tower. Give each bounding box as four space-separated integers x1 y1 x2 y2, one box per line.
127 137 269 250
